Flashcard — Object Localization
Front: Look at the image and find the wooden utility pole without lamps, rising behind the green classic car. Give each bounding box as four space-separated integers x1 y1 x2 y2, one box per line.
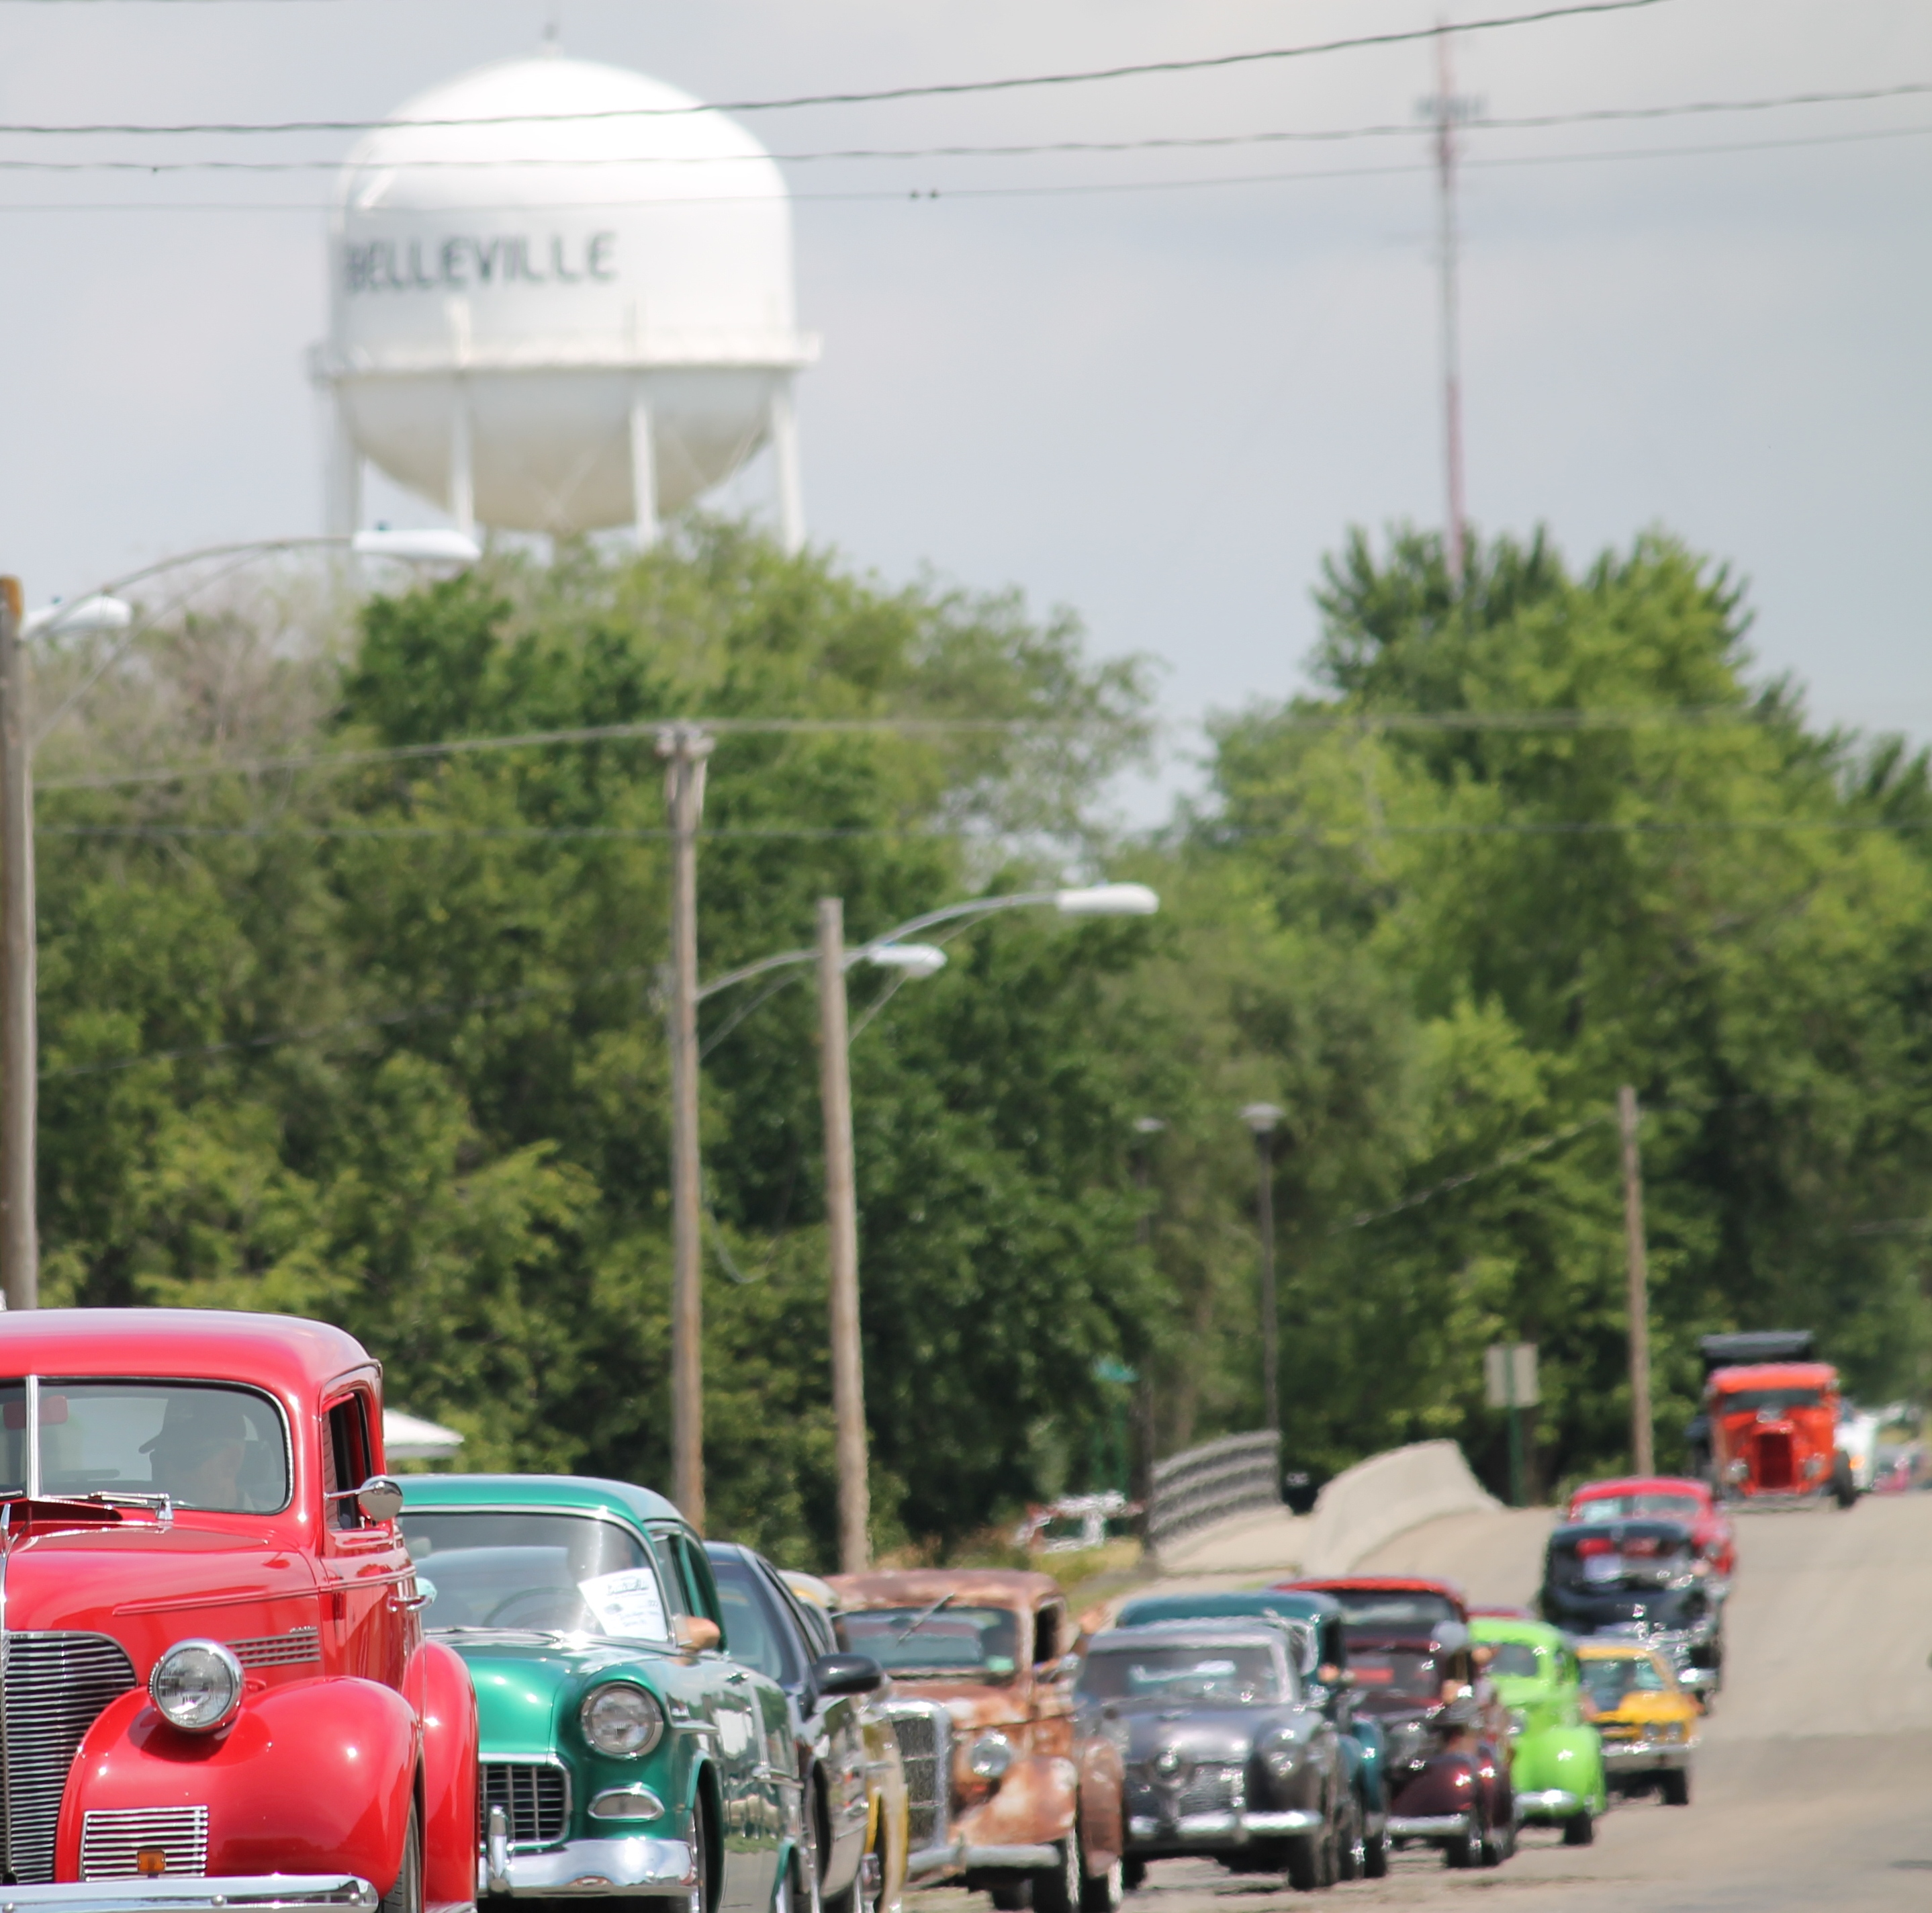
657 725 711 1532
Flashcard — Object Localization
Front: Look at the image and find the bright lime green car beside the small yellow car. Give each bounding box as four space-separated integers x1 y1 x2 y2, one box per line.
1469 1615 1610 1847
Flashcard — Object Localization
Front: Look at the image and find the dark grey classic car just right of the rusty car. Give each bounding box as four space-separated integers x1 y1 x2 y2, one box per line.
1080 1621 1364 1892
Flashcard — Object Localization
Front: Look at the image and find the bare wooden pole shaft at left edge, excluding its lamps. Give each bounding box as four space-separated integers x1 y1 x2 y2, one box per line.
0 578 40 1308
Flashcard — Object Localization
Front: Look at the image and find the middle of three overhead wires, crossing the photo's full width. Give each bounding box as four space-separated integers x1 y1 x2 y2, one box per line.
0 81 1932 172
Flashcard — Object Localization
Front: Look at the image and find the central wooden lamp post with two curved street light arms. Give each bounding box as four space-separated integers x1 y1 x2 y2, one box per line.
691 883 1161 1575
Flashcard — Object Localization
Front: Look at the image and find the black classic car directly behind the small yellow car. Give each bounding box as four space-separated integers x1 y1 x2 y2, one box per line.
1538 1521 1723 1695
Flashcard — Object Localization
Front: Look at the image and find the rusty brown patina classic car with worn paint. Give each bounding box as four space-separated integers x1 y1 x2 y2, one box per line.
831 1569 1123 1913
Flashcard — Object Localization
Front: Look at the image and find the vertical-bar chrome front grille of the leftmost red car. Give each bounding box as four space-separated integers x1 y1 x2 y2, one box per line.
0 1633 138 1886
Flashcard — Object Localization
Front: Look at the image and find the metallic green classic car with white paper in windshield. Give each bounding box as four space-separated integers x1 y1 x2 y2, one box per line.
402 1474 813 1913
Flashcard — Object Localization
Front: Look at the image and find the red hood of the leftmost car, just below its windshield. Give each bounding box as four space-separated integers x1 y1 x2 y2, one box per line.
6 1515 319 1638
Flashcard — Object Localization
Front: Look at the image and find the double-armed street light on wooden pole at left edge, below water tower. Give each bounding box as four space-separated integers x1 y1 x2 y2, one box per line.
0 529 483 1308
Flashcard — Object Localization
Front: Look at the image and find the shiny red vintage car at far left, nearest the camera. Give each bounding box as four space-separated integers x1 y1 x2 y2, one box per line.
0 1308 477 1913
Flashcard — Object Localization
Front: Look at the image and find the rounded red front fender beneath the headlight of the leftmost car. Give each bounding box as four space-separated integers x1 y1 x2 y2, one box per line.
54 1675 421 1894
